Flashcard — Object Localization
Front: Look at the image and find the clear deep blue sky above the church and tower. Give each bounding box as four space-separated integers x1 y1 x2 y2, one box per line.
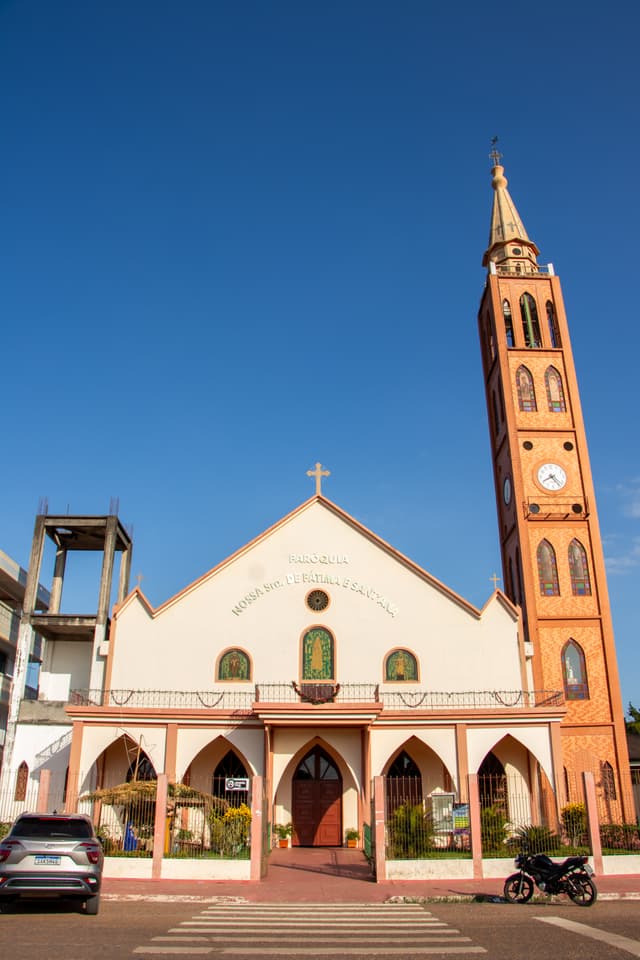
0 0 640 704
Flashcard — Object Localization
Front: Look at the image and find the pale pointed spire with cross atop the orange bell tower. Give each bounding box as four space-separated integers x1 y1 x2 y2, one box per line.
482 137 540 273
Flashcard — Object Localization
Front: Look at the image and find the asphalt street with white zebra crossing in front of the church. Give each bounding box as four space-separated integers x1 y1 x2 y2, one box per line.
0 899 640 960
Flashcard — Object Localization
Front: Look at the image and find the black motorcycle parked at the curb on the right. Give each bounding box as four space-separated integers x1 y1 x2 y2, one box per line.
504 853 598 907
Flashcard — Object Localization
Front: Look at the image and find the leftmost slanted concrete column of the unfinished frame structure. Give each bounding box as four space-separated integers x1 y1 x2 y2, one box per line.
0 515 45 796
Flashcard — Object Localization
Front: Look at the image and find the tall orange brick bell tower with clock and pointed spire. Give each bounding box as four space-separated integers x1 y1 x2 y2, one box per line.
478 149 635 822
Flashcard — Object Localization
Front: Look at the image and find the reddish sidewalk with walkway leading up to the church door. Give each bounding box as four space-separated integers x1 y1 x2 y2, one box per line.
102 847 640 903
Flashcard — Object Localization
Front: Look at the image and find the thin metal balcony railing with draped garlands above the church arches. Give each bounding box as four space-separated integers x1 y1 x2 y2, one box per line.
69 683 564 713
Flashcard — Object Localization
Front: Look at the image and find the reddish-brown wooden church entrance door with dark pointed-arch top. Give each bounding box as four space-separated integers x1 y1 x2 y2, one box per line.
292 747 342 847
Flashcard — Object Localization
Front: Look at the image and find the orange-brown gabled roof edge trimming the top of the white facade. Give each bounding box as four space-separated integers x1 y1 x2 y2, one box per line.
114 494 519 620
